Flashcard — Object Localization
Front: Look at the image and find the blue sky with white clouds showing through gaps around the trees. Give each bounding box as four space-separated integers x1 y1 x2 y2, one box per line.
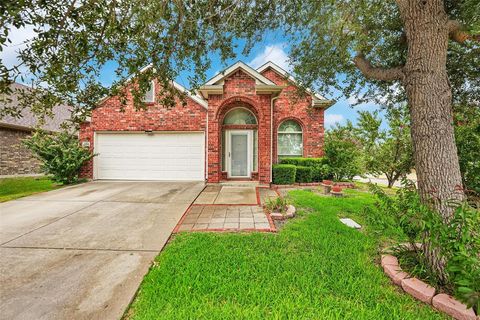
1 28 385 128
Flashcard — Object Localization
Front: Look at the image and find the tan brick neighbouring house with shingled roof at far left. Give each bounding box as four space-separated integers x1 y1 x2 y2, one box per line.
0 83 71 176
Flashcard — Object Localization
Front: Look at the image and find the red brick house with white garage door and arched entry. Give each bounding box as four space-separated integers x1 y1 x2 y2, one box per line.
80 62 333 184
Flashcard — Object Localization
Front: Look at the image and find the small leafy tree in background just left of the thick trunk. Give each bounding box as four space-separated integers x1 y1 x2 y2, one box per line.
354 108 414 187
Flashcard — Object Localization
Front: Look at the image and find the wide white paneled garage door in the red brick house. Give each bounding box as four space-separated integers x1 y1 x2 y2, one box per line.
94 132 205 180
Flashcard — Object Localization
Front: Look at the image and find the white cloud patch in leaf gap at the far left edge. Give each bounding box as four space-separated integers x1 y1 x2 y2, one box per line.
1 26 37 68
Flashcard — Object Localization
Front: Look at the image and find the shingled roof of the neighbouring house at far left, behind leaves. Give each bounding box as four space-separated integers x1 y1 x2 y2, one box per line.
0 83 72 132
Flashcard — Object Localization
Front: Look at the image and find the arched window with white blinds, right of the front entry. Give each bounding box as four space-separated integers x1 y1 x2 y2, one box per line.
277 120 303 158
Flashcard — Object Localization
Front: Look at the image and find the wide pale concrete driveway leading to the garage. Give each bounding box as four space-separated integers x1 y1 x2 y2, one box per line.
0 181 204 319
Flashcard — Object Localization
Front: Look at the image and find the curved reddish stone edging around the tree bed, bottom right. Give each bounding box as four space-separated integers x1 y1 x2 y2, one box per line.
381 254 480 320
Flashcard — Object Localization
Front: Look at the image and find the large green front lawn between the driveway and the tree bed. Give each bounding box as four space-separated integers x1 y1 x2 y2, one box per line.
127 191 443 319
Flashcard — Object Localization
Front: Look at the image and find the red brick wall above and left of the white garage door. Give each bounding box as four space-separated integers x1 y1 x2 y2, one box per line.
79 80 207 178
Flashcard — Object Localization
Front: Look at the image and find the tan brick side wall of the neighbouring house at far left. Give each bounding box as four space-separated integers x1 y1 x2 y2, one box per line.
0 128 41 176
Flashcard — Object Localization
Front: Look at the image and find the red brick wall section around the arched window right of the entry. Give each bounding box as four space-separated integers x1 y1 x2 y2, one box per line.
262 68 324 163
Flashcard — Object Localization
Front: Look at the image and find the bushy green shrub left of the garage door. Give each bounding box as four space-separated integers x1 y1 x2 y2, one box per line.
24 131 93 184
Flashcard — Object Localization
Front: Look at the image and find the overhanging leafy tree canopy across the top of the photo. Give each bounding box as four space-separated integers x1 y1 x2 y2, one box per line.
0 0 480 121
